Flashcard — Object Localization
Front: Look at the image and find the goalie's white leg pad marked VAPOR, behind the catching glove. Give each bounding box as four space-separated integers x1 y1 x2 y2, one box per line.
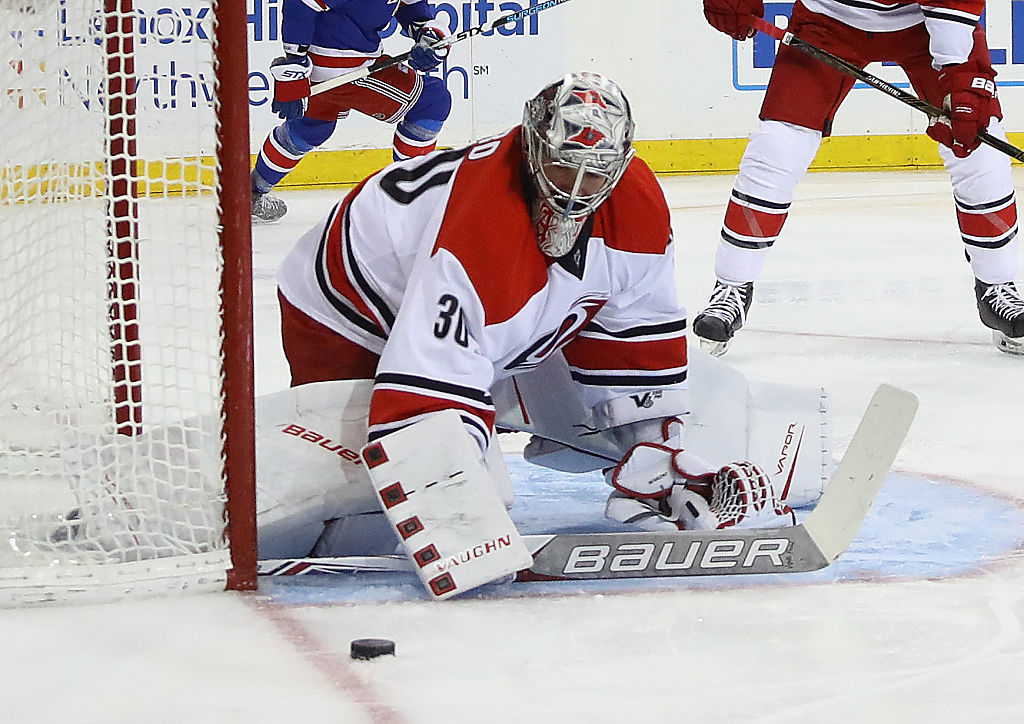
492 348 835 507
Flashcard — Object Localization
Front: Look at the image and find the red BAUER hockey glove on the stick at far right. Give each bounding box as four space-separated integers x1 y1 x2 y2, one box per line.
927 60 999 159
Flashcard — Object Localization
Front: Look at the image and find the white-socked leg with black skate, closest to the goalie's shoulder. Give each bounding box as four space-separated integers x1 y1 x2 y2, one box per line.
693 121 821 356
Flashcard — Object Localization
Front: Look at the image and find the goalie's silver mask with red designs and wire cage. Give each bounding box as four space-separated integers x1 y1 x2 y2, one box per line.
522 73 635 258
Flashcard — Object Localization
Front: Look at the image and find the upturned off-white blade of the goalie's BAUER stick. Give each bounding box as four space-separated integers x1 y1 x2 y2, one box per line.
804 384 918 563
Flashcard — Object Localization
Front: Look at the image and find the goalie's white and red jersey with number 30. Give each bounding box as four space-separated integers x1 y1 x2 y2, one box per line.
279 127 686 448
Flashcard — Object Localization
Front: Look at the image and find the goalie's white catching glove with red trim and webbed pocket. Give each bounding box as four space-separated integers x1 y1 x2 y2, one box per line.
604 419 797 530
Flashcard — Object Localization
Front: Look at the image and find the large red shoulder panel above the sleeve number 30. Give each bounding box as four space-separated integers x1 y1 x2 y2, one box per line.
433 127 548 325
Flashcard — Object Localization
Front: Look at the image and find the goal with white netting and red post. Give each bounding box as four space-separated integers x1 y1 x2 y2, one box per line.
0 0 255 605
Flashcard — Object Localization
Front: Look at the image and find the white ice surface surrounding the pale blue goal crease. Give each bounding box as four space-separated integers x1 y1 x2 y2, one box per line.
0 170 1024 724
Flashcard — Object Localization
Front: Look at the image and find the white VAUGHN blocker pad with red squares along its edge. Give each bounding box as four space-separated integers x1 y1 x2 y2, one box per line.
362 411 534 600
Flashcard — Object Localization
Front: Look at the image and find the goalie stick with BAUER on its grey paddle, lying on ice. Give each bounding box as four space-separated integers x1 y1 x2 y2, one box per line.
259 385 918 581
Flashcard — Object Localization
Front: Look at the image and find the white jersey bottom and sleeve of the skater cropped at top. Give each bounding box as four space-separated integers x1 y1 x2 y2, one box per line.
801 0 985 68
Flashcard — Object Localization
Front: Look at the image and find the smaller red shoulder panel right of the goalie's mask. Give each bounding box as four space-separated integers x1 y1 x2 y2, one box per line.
593 158 672 254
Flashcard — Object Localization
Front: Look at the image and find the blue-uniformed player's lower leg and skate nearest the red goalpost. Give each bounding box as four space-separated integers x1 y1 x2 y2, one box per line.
251 117 337 223
